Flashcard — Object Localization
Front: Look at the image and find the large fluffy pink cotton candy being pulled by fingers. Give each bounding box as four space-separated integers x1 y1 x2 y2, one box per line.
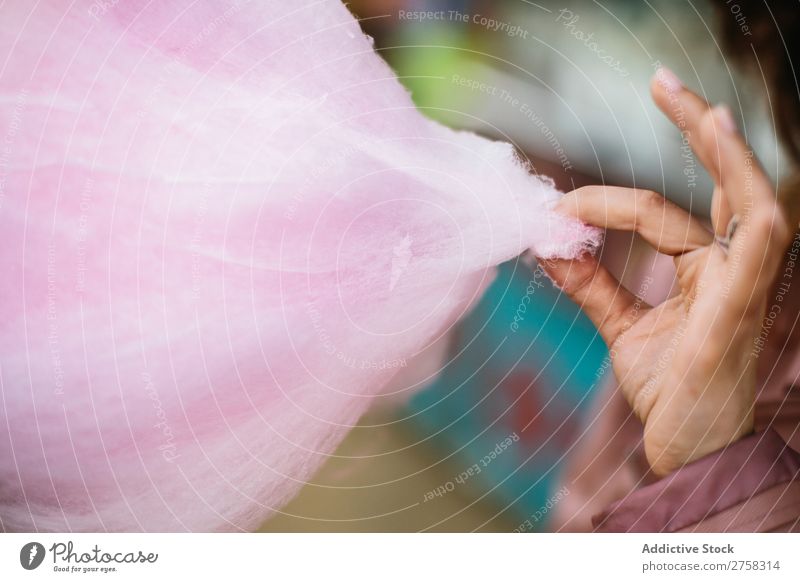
0 0 600 531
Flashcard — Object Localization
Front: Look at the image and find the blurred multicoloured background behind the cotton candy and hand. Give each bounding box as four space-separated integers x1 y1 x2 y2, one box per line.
262 0 784 531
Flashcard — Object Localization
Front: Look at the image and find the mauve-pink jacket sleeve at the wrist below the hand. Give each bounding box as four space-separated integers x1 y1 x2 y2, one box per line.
592 430 800 532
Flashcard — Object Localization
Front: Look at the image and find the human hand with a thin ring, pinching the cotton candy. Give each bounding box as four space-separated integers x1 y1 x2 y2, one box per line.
542 69 798 475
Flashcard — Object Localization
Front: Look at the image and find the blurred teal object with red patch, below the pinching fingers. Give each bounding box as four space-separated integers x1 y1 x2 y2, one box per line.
405 262 607 530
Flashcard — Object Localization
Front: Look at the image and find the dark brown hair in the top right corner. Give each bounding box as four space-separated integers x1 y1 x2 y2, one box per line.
713 0 800 169
